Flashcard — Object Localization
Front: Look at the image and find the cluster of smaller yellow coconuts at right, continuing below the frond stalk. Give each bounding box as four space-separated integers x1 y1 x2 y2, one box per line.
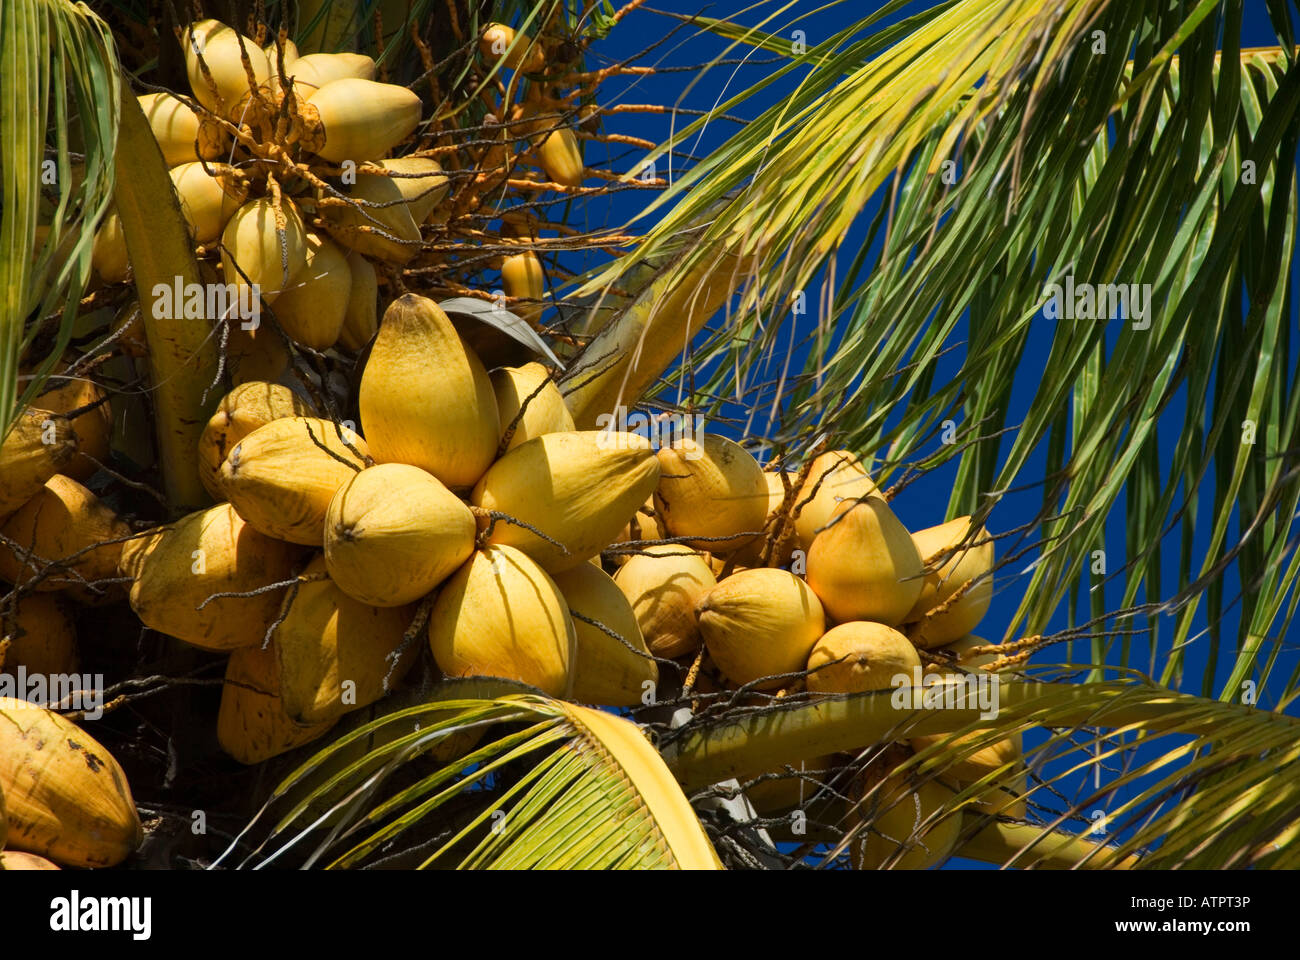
615 436 1024 866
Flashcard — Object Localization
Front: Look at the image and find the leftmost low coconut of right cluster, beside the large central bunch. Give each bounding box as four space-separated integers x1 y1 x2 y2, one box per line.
614 544 718 658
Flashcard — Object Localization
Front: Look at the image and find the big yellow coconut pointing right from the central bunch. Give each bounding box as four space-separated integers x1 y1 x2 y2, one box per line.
471 431 659 572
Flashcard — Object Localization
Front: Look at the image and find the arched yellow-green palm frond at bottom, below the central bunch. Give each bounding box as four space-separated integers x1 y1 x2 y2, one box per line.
220 680 719 869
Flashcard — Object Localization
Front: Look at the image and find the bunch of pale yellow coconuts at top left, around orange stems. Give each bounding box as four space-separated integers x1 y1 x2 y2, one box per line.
92 20 449 361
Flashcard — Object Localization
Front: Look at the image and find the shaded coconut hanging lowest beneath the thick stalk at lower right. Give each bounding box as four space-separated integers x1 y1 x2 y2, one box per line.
853 777 962 870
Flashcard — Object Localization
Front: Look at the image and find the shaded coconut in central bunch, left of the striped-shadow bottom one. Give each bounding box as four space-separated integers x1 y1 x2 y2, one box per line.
274 548 419 726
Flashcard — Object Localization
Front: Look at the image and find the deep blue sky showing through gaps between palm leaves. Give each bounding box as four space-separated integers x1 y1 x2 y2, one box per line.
566 0 1296 858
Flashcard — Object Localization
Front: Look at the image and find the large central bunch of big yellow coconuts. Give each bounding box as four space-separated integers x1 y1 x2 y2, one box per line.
109 294 659 762
